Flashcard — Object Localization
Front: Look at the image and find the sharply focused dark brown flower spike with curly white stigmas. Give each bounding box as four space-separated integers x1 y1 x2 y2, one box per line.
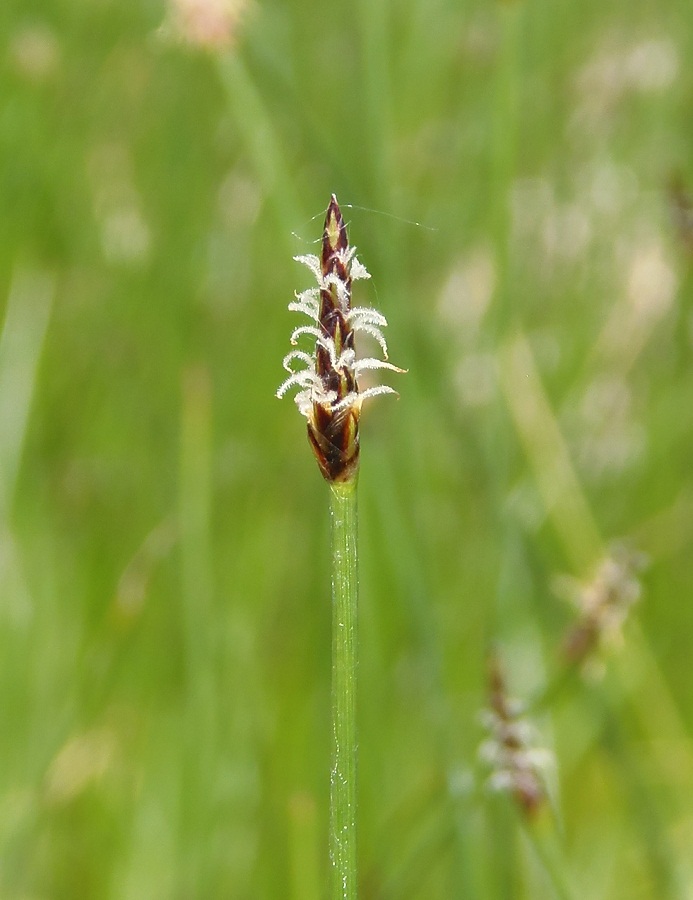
277 194 405 482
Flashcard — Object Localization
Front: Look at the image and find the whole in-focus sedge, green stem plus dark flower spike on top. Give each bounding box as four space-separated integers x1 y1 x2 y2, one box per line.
277 194 404 900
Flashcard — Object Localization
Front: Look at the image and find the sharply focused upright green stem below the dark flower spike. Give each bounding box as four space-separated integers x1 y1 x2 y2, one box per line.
330 480 358 900
